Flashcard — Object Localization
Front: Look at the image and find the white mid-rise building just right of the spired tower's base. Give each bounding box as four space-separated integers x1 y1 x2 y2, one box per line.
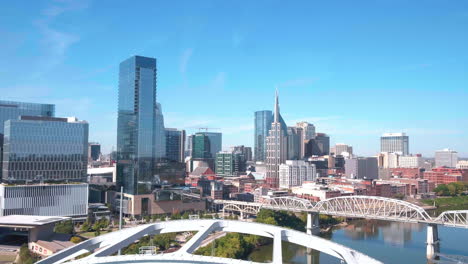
279 160 316 189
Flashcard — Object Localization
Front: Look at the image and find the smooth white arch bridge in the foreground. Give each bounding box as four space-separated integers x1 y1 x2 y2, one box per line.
37 220 381 264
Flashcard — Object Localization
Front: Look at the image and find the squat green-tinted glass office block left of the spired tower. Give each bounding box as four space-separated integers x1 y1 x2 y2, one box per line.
215 151 246 177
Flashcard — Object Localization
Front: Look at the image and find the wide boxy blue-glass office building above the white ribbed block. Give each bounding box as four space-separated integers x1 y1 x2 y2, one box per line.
3 116 89 182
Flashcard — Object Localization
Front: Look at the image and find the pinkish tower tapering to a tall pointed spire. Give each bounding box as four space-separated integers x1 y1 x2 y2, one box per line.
265 91 288 188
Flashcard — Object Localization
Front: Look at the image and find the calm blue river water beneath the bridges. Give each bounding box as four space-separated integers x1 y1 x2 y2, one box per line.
249 220 468 264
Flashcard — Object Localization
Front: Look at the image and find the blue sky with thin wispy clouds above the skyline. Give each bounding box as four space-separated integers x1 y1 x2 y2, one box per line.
0 0 468 156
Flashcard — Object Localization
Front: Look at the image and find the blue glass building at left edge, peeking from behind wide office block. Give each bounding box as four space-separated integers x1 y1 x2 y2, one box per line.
0 100 55 177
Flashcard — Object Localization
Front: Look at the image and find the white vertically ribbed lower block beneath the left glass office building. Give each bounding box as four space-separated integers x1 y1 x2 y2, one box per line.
0 183 88 217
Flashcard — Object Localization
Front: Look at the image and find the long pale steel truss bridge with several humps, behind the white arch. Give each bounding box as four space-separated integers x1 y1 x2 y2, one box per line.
214 196 468 228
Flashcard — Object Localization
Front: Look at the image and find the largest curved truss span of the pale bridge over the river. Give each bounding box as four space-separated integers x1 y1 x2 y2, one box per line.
313 196 432 222
